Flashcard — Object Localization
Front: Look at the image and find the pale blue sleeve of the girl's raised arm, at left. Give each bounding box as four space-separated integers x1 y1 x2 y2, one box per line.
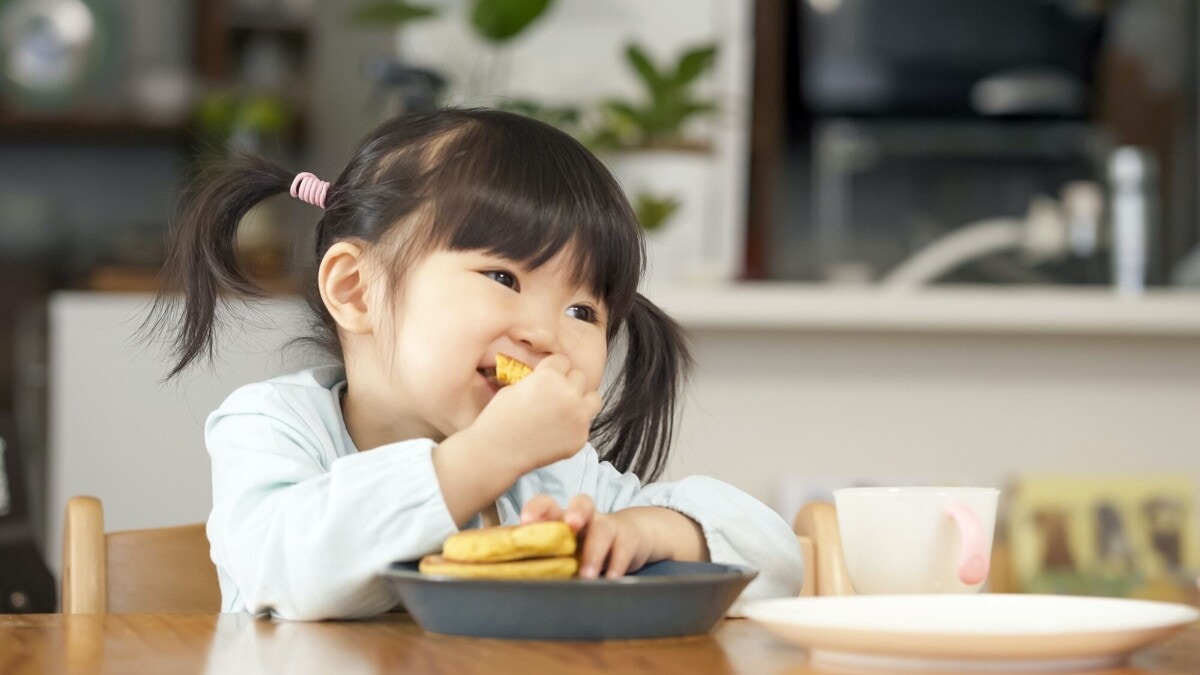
206 401 457 620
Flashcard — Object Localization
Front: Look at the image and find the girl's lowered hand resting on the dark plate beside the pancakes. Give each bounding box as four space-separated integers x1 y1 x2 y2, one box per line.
521 495 708 579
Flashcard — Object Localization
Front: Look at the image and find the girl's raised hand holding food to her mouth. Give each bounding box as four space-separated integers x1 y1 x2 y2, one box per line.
472 354 601 471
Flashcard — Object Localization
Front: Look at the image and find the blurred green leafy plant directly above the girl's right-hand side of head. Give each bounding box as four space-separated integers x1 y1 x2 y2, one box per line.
590 43 716 149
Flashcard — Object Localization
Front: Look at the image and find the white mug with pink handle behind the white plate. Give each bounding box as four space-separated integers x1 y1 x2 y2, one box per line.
834 488 1000 595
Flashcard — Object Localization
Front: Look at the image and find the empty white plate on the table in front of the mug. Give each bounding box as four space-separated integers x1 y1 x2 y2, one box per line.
744 593 1200 670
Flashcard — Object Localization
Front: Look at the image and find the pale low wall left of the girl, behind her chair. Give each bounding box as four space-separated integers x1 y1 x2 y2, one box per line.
46 292 306 571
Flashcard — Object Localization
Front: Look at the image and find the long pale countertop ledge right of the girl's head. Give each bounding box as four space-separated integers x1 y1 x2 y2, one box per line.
646 282 1200 339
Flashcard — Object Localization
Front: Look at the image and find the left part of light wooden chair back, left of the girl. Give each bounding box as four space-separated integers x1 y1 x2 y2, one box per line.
62 497 221 614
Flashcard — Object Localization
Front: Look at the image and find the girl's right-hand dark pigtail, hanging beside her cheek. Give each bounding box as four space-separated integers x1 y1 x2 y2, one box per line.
592 293 692 482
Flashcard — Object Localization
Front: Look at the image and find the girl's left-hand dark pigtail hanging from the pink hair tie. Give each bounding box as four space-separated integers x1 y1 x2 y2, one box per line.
142 155 293 380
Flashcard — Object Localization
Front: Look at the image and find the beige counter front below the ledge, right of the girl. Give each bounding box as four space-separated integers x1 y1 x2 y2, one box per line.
672 330 1200 513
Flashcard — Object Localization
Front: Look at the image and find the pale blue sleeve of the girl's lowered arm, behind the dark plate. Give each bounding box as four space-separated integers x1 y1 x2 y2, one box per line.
515 446 804 602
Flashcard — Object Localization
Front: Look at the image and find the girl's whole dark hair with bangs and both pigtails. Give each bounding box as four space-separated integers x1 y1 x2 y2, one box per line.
148 108 691 480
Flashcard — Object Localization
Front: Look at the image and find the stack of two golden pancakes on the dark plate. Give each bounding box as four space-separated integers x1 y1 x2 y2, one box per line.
420 520 580 579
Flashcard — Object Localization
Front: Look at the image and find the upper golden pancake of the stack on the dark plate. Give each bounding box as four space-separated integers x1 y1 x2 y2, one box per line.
442 520 575 562
